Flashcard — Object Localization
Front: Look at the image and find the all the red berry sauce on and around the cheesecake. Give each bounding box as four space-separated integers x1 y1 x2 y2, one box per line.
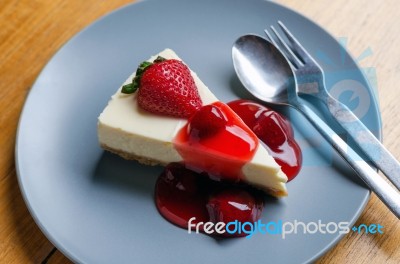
155 100 302 236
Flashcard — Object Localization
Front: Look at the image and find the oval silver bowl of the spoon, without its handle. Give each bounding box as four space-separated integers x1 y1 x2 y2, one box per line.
232 35 295 105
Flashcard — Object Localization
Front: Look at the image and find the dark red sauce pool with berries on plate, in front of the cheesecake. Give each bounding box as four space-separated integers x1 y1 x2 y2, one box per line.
155 163 264 237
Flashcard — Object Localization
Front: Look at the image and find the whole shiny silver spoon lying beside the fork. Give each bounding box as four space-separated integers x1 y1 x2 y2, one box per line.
232 35 400 219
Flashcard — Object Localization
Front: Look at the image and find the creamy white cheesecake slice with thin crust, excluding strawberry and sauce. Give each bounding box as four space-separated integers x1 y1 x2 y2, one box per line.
98 49 287 197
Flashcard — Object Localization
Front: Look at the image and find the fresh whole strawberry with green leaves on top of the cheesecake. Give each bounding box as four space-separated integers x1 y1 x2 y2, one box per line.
122 57 202 118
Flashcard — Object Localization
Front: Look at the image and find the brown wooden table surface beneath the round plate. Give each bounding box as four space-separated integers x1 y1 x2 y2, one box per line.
0 0 400 263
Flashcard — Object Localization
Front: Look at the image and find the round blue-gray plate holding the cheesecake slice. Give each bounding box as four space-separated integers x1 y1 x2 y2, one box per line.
16 0 381 264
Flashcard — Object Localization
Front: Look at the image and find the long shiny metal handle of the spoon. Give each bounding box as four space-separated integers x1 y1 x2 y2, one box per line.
293 103 400 219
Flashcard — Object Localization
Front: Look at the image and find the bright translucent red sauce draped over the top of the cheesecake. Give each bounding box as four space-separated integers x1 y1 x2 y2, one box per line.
174 102 258 181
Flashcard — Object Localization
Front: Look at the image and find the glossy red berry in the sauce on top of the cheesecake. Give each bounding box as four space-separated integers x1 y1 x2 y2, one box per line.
189 105 227 138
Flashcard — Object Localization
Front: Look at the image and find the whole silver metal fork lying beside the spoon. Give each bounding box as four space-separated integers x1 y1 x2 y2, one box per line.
264 21 400 189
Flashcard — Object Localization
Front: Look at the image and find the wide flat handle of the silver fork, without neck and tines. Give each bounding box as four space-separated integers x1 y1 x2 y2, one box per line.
325 94 400 190
